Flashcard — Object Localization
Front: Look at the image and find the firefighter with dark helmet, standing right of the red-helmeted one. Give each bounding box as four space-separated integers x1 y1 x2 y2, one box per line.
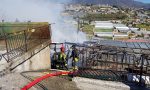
70 45 79 70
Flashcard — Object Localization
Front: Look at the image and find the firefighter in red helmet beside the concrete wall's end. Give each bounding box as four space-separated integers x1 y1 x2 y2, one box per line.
57 46 67 70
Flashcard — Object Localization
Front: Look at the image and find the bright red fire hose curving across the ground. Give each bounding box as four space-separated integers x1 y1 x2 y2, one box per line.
21 71 73 90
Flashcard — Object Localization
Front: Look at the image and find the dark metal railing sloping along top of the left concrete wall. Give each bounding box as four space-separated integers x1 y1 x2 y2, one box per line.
1 24 51 62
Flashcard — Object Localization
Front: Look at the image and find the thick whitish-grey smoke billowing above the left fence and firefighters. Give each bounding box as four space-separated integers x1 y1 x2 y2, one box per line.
0 0 86 42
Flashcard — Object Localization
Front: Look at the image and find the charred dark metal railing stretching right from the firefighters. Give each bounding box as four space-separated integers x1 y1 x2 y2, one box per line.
79 41 150 85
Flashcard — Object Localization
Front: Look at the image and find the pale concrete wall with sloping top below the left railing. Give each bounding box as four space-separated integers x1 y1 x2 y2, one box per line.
0 44 51 75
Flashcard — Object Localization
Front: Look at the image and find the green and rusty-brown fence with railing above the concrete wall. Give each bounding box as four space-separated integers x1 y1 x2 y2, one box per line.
0 23 51 62
